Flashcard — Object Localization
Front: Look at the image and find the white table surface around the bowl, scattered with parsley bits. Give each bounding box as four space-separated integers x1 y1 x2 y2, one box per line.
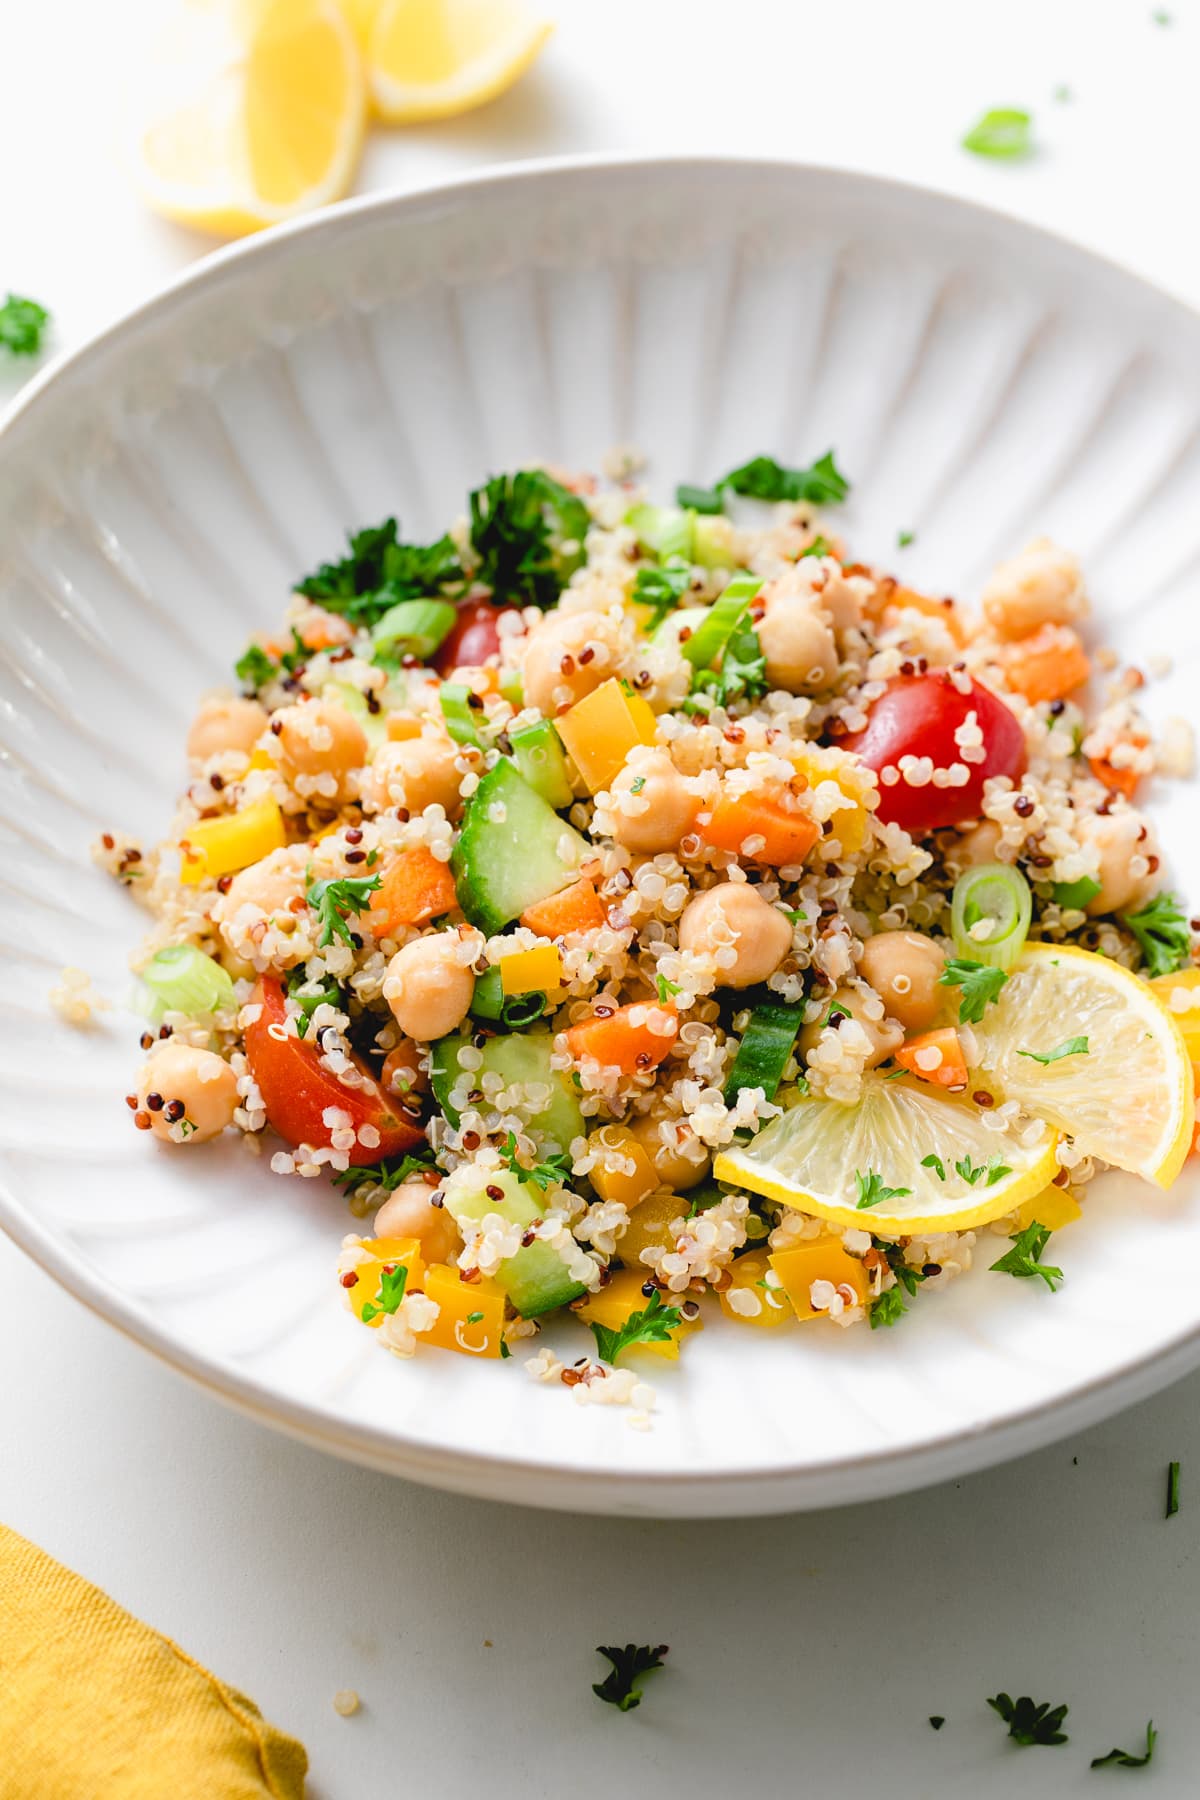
0 0 1200 1800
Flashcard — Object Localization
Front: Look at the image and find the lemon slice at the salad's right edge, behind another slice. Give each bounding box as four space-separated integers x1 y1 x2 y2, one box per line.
972 943 1195 1188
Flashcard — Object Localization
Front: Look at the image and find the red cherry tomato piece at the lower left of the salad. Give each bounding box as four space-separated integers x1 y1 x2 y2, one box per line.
246 976 425 1163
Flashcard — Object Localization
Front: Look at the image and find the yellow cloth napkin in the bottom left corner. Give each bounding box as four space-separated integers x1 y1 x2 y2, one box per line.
0 1525 308 1800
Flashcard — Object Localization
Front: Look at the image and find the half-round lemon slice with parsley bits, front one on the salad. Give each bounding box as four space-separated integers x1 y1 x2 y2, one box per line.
712 1075 1058 1237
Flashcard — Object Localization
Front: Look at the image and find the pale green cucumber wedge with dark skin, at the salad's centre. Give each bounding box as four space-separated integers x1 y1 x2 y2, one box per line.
450 761 588 936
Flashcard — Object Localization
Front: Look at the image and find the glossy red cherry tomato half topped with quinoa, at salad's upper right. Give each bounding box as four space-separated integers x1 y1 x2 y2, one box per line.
838 670 1025 835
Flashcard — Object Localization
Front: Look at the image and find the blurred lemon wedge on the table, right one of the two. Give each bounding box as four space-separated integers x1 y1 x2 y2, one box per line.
367 0 554 124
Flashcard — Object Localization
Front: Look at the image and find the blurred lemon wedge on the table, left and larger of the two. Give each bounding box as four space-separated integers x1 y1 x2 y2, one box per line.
133 0 367 236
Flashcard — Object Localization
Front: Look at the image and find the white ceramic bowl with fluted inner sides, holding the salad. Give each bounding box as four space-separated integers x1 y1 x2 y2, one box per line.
0 160 1200 1514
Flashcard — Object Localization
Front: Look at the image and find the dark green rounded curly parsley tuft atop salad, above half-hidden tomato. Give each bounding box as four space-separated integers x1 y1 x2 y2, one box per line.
470 468 590 608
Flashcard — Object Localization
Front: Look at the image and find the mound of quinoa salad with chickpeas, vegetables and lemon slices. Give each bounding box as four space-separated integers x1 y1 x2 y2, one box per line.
94 454 1200 1424
